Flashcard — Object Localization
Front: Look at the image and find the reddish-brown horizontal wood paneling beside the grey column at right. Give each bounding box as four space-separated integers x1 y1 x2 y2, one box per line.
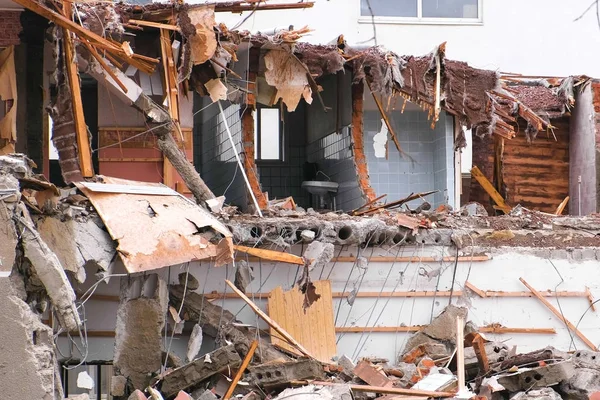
470 117 569 213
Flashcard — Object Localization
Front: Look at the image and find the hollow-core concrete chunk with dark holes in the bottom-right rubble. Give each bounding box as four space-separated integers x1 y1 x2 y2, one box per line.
498 361 575 392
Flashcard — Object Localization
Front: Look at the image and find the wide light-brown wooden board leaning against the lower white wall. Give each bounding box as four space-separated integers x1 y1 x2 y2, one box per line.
268 281 337 362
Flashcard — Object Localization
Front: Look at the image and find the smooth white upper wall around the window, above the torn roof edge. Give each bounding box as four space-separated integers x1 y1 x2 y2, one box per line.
212 0 600 77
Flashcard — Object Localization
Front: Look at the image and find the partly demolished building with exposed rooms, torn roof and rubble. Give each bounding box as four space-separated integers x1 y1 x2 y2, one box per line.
0 0 600 399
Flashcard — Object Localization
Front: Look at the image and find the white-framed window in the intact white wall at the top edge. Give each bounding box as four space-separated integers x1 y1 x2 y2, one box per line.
360 0 482 24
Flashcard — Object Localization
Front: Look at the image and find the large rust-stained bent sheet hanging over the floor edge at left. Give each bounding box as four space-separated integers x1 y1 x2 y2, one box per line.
76 176 233 273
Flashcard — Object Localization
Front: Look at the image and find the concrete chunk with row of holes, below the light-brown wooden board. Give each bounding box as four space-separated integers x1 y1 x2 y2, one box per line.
248 360 325 386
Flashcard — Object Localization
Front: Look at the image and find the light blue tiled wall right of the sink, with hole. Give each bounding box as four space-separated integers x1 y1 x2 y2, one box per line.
364 110 454 208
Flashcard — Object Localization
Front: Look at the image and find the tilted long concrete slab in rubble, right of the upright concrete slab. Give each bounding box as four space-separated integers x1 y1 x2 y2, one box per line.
161 345 242 397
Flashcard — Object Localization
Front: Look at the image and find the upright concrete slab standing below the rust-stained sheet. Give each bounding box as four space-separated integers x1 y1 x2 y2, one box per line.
114 274 169 389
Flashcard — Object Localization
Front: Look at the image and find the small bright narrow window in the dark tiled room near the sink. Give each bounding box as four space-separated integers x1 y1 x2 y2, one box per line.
254 107 284 161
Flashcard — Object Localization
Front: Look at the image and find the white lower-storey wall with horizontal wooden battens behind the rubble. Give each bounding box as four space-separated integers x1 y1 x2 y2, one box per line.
59 247 600 362
